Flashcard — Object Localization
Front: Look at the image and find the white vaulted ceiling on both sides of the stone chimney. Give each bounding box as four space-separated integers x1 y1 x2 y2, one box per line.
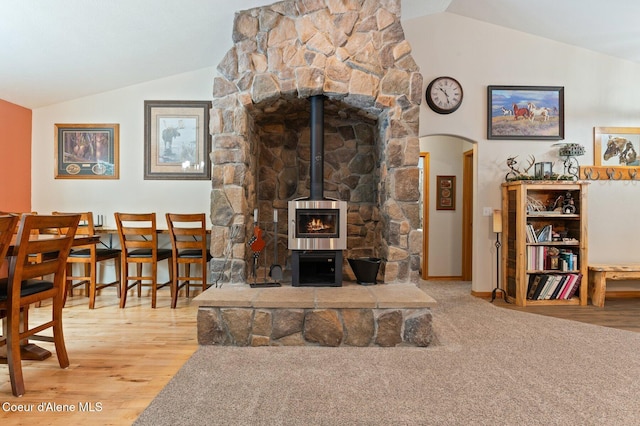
0 0 640 108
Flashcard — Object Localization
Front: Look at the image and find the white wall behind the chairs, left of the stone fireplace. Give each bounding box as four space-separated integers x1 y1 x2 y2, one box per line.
31 68 215 227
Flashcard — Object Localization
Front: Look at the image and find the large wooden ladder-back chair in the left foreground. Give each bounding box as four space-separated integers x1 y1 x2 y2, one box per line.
0 215 80 396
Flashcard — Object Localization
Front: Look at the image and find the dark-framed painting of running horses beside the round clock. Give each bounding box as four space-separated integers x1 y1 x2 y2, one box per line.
487 86 564 140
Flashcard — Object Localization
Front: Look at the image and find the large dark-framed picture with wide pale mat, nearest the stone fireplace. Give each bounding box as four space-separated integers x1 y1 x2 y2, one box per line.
144 101 211 180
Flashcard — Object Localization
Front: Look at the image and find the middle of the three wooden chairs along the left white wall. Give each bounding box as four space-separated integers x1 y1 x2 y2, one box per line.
114 213 173 308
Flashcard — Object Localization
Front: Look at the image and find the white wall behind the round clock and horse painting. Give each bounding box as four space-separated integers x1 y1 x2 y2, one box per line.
403 13 640 292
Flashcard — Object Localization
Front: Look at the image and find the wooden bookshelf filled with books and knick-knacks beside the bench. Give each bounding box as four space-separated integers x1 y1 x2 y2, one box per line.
502 181 589 306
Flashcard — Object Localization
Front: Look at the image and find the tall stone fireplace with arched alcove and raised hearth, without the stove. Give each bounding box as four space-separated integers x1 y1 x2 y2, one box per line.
196 0 433 346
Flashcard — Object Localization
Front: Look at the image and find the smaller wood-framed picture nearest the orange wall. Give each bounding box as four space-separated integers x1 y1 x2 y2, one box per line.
53 123 120 179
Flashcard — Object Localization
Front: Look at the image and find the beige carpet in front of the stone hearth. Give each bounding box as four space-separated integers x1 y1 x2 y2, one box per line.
135 282 640 426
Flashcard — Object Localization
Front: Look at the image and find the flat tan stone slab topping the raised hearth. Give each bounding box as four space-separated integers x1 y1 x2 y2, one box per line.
191 282 437 309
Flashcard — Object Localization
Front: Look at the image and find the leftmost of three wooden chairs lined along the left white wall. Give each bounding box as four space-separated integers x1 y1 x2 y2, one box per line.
53 212 122 309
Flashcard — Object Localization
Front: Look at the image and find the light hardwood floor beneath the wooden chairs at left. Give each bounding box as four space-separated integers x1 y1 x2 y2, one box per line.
0 288 198 426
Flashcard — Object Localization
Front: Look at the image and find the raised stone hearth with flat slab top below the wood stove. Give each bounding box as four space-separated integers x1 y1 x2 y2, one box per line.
193 283 436 347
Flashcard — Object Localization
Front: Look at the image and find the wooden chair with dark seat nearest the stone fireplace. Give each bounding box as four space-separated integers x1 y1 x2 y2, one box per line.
166 213 212 309
